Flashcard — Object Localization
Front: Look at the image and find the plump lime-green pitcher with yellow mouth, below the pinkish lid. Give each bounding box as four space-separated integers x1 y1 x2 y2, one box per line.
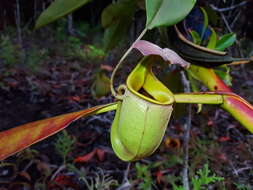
111 56 174 161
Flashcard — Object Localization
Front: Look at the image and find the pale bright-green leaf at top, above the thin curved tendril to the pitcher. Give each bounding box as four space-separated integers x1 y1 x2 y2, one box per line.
146 0 196 29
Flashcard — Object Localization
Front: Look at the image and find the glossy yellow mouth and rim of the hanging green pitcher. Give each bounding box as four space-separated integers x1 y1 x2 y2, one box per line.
127 56 174 105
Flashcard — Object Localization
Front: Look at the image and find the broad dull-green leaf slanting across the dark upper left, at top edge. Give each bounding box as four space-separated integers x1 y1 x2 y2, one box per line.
35 0 91 29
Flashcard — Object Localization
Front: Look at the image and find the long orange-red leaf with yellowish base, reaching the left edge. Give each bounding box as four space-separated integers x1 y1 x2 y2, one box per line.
0 102 117 160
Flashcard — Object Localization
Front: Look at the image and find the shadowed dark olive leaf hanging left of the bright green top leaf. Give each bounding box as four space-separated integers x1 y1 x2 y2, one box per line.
101 0 137 50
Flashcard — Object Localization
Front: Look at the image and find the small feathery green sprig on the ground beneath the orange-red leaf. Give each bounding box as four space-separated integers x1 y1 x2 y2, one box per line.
54 130 75 164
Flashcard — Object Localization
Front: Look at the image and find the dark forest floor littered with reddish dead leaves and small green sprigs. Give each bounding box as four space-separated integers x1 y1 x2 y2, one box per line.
0 24 253 190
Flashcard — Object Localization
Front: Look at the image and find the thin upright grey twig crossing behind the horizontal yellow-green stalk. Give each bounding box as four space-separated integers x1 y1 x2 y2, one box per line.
181 71 191 190
